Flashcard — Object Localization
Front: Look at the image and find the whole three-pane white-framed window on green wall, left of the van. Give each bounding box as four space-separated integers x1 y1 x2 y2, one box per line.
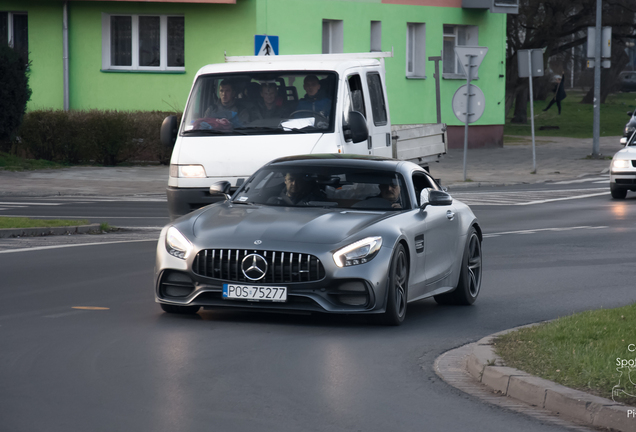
102 14 185 71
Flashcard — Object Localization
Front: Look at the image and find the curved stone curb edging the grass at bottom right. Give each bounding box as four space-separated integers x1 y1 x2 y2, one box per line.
466 330 636 432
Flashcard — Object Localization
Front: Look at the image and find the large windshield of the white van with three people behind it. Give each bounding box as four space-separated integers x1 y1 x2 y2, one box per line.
181 71 337 135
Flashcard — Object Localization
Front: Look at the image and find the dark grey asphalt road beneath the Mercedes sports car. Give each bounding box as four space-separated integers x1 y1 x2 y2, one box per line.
0 183 636 432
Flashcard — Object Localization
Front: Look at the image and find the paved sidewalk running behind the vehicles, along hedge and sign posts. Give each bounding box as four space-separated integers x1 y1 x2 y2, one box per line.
0 137 622 196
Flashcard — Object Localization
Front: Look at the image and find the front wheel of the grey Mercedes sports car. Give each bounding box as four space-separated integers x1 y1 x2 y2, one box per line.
382 243 409 326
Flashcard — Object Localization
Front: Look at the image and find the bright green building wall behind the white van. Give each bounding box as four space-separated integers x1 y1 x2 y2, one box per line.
13 0 506 130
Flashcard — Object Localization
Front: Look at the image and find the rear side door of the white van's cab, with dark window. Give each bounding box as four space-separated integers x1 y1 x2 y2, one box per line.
366 71 393 157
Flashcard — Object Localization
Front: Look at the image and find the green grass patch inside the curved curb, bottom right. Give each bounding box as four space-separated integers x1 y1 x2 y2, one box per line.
495 304 636 405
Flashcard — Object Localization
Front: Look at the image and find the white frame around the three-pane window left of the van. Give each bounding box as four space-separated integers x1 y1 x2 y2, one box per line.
102 13 185 72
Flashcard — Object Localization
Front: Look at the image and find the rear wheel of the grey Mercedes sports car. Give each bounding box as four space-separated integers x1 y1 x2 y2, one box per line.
433 227 482 305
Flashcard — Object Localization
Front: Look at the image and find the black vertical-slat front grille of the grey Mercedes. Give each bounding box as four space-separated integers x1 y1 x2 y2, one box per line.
192 249 325 283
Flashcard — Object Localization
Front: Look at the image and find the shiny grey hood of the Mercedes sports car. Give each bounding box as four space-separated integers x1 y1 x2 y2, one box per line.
192 202 396 248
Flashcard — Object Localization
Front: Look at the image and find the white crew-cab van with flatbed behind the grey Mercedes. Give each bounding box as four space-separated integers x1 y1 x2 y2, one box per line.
161 53 446 219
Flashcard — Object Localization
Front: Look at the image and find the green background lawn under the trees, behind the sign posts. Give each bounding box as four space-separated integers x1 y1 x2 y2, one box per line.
504 89 636 138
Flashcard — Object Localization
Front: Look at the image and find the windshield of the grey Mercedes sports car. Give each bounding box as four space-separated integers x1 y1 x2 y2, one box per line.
232 165 410 211
